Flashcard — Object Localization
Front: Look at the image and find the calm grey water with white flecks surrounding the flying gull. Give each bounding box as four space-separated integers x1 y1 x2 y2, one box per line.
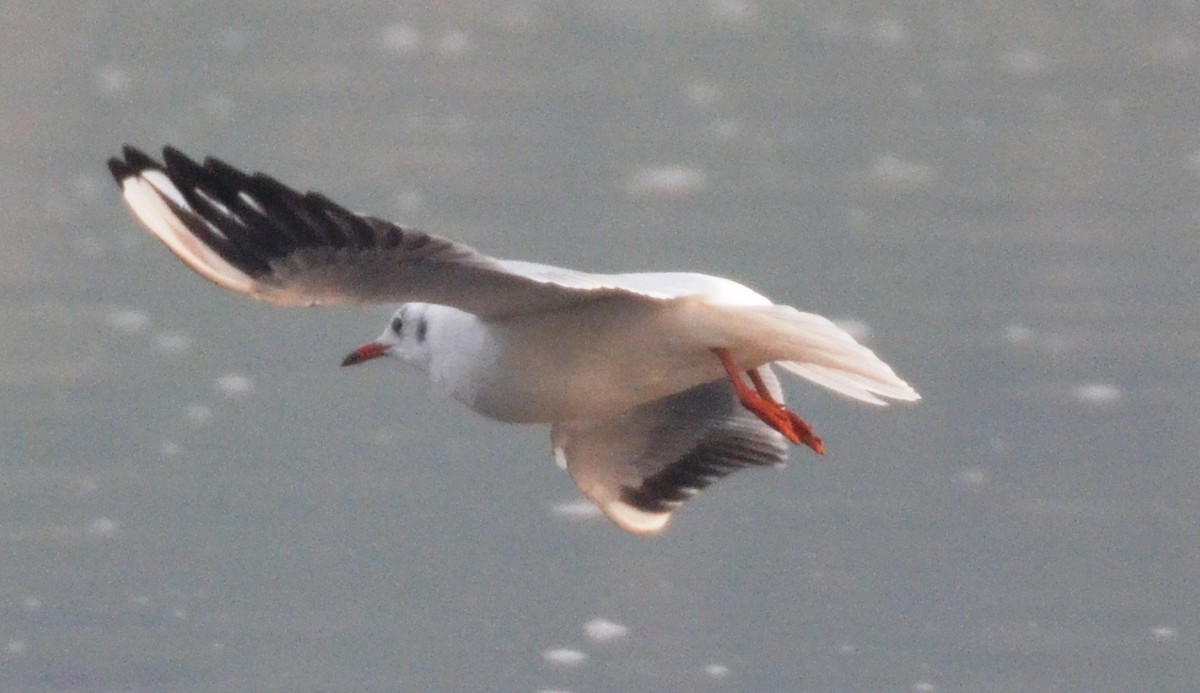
0 5 1200 693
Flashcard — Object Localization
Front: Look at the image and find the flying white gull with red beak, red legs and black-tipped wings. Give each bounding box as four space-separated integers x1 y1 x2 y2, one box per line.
108 146 920 535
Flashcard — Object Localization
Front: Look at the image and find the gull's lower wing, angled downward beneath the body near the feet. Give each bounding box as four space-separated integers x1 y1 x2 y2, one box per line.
551 366 787 534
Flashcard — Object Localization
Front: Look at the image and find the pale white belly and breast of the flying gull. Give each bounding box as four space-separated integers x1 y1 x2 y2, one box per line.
430 301 724 422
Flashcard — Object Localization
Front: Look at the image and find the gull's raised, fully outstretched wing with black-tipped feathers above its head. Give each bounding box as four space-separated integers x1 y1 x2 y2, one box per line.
108 146 670 317
